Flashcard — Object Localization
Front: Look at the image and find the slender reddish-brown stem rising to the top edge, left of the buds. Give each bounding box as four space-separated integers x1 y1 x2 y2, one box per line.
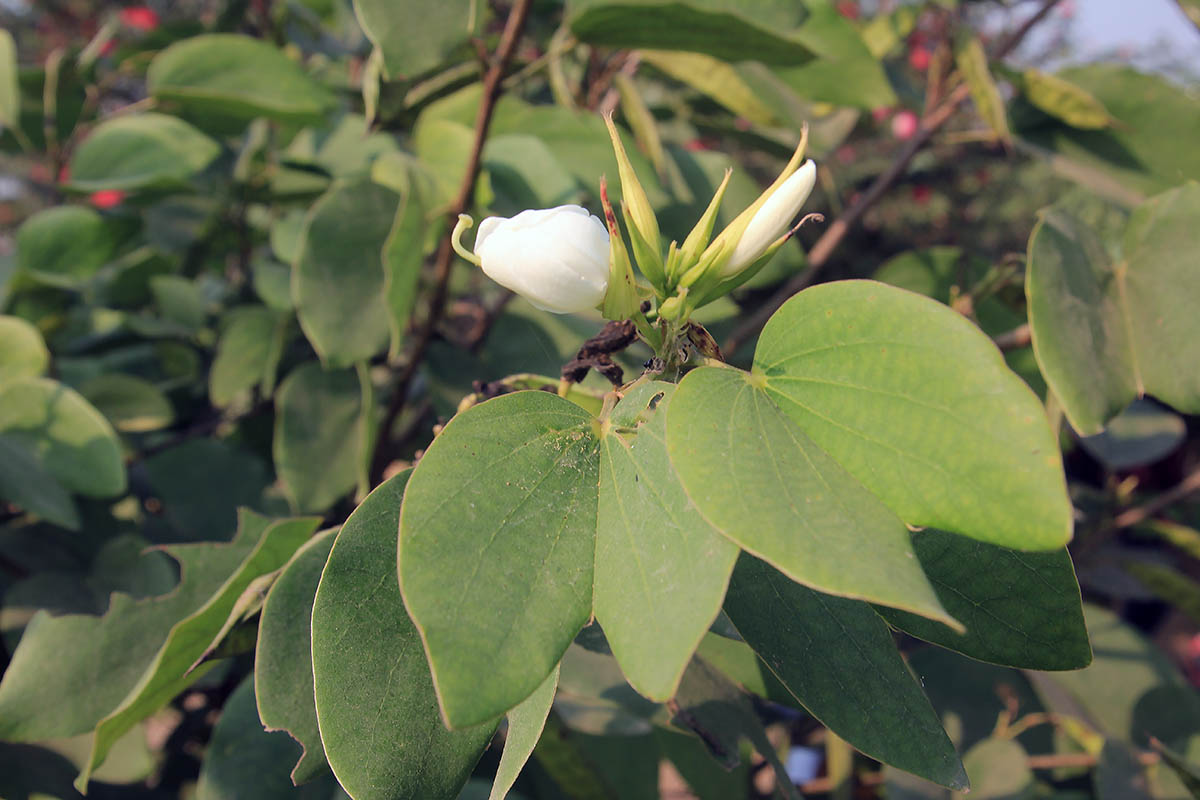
371 0 532 486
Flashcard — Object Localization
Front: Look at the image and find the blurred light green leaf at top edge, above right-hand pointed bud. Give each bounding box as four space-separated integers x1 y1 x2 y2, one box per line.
775 2 900 109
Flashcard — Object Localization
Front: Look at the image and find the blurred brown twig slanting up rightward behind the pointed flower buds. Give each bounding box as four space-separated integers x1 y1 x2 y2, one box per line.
724 0 1060 354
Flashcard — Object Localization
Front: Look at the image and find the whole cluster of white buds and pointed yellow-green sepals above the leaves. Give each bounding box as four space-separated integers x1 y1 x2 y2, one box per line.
454 119 816 327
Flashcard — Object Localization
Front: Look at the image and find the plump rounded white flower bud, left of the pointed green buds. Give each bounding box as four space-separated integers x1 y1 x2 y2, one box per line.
475 205 608 314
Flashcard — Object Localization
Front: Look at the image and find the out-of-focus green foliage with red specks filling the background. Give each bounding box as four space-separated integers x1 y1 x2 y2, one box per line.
0 0 1200 800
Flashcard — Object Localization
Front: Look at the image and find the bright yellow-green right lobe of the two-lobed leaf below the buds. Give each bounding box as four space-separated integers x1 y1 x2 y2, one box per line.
754 281 1072 549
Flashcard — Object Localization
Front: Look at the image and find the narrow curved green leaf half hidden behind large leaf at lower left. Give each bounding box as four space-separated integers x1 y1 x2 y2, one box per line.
254 530 335 786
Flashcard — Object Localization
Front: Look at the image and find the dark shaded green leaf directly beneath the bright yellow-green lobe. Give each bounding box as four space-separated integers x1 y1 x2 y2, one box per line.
877 528 1092 669
